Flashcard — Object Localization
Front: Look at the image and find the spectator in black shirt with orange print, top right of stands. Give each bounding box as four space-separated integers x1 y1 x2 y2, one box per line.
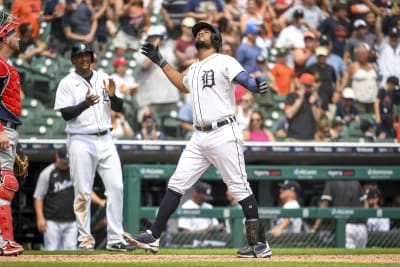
319 2 350 57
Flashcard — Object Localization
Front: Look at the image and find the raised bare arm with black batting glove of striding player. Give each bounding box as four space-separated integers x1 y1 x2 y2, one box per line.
142 43 189 94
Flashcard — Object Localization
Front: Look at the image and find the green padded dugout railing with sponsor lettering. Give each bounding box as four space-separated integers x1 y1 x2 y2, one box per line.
123 164 400 248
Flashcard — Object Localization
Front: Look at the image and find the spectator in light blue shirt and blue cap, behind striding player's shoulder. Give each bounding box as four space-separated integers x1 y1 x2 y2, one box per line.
236 24 261 73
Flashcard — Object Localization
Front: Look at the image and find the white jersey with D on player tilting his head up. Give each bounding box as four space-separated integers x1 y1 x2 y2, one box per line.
183 53 244 126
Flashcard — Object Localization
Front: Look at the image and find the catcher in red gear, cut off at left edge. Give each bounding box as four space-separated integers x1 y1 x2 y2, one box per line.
0 12 24 256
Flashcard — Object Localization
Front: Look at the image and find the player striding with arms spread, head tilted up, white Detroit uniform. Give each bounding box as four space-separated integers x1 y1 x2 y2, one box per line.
124 22 271 258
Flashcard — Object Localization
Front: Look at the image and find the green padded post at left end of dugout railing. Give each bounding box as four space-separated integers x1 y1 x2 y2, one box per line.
123 165 141 233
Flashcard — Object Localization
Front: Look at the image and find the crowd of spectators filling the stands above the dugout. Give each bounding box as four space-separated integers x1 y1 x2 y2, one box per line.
2 0 400 142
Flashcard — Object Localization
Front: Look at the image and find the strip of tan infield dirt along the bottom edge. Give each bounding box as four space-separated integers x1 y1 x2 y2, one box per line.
0 254 400 264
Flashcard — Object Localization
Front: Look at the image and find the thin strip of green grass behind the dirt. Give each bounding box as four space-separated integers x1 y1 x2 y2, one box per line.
24 248 400 256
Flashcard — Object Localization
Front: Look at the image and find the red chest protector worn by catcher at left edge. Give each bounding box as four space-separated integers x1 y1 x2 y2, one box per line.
0 58 21 117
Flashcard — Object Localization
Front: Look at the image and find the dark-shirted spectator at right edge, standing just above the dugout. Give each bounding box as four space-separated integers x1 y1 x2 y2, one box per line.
374 76 399 139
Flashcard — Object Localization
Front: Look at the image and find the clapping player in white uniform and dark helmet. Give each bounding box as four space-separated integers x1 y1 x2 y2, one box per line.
54 42 133 251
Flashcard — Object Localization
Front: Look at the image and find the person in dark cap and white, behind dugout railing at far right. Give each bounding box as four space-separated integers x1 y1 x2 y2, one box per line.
366 188 390 232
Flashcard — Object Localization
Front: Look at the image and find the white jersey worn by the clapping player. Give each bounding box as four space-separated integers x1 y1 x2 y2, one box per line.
54 70 112 134
